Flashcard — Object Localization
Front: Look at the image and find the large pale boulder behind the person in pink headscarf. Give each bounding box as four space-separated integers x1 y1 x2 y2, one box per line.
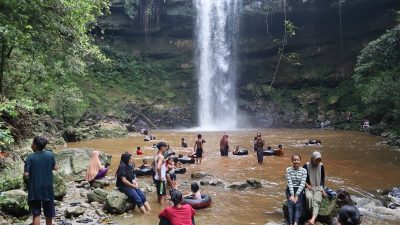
55 148 111 181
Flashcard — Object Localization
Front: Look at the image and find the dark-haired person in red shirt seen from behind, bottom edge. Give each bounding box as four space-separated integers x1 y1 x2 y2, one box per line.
158 190 196 225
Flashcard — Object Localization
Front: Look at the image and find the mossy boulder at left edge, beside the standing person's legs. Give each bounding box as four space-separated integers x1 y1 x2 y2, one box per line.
0 189 29 217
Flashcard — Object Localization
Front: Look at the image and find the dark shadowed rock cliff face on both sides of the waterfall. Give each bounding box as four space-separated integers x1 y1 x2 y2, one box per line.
98 0 400 127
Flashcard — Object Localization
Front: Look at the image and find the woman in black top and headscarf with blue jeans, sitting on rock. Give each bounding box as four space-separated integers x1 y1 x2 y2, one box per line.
115 153 151 213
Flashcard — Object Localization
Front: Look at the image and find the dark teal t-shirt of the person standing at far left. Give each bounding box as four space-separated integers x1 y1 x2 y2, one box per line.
24 151 56 201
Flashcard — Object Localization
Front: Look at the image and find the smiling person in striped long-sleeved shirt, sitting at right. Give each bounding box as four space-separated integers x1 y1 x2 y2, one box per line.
286 154 307 225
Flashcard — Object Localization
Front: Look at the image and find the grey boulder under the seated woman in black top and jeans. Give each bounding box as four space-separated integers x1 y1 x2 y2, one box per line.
105 190 134 214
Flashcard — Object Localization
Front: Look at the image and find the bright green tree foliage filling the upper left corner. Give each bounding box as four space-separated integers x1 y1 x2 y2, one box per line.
0 0 109 99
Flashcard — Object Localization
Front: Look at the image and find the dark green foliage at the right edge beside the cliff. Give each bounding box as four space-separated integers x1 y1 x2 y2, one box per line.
354 25 400 124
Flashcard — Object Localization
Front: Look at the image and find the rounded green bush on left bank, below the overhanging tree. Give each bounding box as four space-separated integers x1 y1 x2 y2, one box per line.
53 87 87 126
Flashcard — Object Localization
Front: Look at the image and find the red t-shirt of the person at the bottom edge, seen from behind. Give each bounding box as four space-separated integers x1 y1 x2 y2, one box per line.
158 204 196 225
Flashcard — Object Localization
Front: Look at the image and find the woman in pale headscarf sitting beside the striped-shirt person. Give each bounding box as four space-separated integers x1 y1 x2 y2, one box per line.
303 151 326 225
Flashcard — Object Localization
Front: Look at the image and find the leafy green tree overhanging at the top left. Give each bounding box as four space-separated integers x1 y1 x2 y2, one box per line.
0 0 109 97
